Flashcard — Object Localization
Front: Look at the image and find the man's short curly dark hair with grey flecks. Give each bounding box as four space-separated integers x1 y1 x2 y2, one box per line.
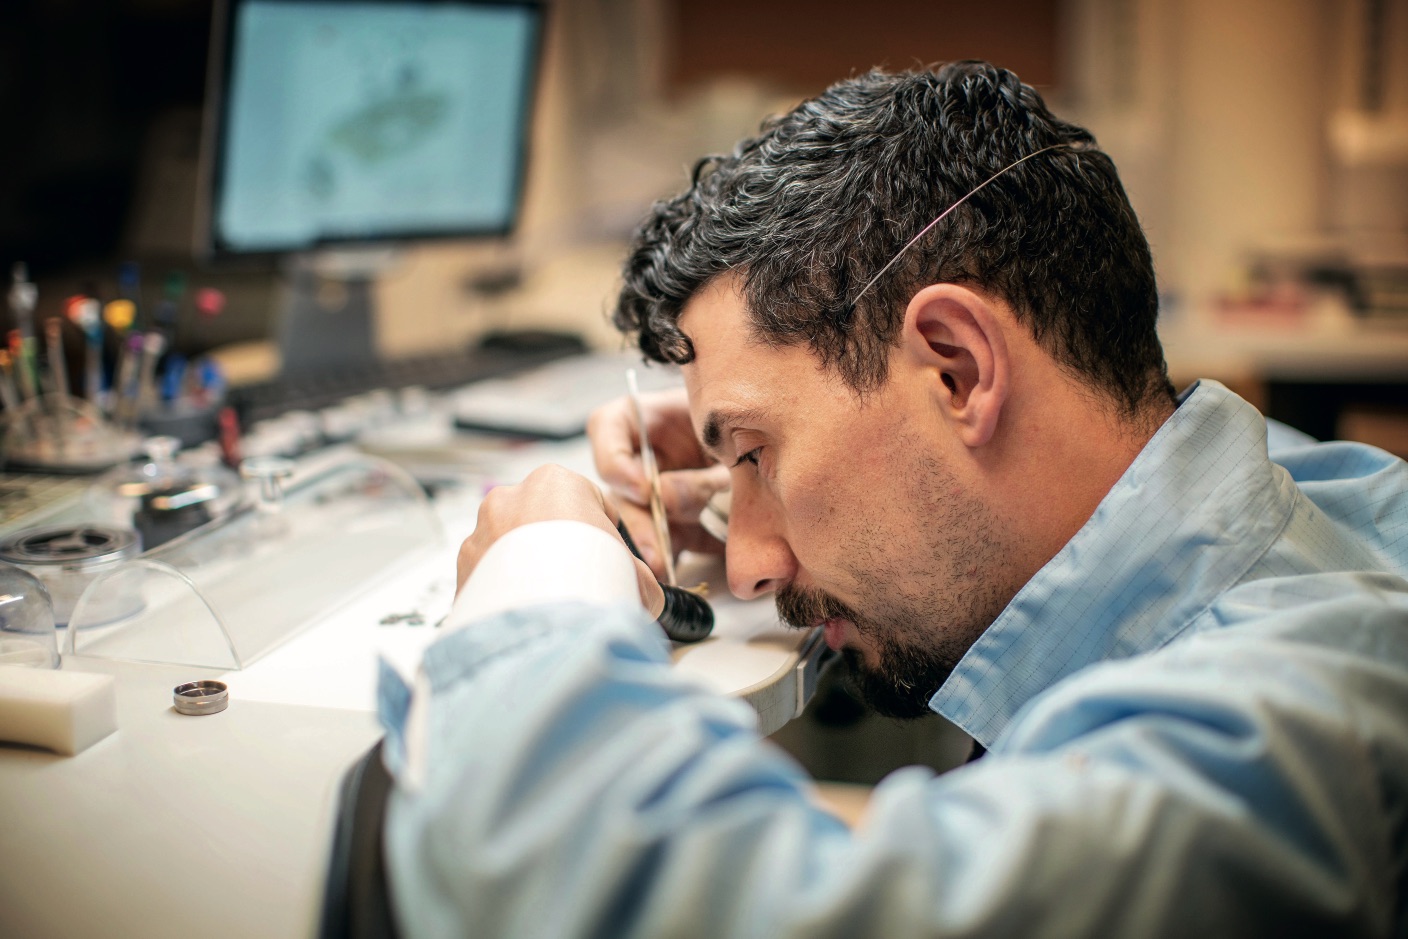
614 62 1173 415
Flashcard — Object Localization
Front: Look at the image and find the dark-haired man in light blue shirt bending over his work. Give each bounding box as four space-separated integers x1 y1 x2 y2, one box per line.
383 63 1408 938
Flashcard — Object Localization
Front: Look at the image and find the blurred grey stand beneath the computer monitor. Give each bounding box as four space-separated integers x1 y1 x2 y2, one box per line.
279 251 393 380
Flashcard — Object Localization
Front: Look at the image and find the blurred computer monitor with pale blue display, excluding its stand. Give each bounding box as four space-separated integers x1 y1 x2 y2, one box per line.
203 0 542 255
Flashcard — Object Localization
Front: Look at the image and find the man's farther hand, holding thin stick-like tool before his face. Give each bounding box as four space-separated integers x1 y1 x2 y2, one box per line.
587 389 728 577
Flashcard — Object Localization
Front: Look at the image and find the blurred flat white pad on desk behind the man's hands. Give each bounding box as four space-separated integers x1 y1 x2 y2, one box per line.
453 352 683 441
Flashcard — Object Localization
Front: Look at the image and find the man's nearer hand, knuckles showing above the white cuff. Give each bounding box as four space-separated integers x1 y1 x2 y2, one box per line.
455 466 665 617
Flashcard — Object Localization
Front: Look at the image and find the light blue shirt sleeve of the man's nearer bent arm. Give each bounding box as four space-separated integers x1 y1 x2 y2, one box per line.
374 582 1408 939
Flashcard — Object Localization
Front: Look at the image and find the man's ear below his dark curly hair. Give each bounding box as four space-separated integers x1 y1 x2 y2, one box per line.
901 283 1012 446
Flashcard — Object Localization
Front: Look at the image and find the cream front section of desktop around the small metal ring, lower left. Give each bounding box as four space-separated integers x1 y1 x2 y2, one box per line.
0 660 380 939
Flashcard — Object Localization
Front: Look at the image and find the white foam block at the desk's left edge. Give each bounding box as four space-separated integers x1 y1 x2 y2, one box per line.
0 664 117 756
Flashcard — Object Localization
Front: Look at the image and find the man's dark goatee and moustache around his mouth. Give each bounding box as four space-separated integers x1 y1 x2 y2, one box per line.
777 584 976 719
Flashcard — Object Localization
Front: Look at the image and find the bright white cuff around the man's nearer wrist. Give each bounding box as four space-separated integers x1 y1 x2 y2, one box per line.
444 519 641 629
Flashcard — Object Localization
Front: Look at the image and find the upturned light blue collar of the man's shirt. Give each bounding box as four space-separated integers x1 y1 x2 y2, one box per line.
929 382 1290 746
